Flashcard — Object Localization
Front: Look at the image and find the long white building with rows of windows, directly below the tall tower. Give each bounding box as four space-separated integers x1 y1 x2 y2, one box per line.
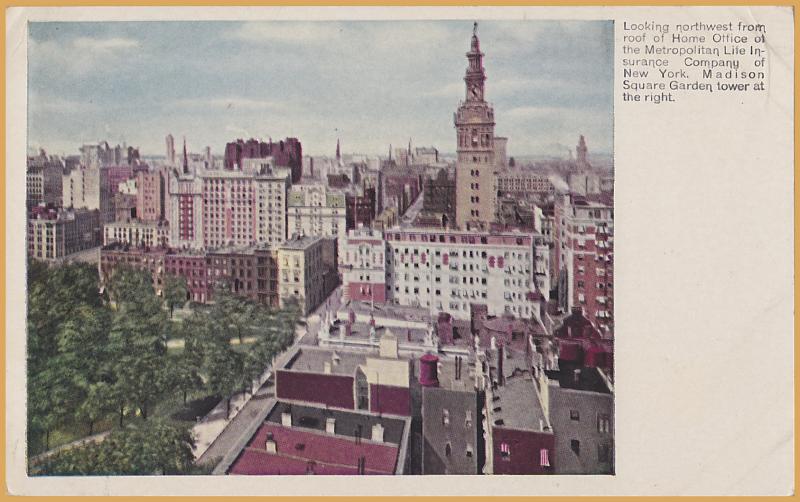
386 228 549 319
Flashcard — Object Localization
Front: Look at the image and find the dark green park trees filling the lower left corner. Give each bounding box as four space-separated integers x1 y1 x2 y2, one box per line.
27 262 300 474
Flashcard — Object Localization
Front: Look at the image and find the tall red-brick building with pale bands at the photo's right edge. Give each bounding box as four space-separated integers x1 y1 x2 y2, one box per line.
554 194 614 337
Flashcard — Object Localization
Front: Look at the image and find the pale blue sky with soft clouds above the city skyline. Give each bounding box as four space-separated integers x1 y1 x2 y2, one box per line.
28 20 613 156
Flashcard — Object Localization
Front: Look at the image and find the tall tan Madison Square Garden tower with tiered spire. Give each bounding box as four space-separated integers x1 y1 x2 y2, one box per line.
453 23 495 229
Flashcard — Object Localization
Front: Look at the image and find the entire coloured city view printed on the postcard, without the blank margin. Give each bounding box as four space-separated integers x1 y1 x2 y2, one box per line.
20 19 615 477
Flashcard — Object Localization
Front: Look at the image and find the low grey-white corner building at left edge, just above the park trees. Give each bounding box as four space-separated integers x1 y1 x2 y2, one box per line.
28 207 101 261
